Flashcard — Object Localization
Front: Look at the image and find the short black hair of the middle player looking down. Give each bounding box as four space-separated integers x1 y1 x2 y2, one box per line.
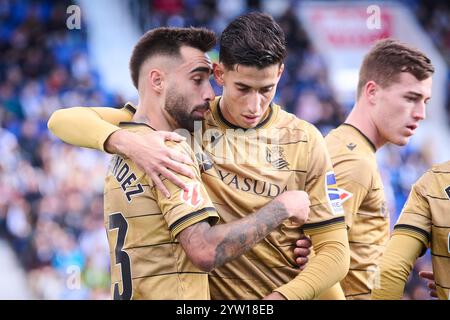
219 12 286 70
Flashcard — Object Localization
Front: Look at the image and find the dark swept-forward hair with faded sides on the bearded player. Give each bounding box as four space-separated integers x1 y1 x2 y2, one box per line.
130 27 217 89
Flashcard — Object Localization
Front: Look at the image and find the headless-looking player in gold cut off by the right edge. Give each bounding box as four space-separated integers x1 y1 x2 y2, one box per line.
372 161 450 300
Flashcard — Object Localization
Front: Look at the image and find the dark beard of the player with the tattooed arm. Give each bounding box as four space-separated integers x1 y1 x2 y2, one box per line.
164 90 209 132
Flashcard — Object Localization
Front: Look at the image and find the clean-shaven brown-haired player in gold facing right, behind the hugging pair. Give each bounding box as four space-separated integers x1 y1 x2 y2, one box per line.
325 39 434 299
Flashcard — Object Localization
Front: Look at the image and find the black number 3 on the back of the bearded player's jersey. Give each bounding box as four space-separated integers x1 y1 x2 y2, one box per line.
109 212 133 300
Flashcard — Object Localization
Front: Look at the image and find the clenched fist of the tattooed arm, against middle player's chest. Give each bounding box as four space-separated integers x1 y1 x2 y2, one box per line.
274 191 311 225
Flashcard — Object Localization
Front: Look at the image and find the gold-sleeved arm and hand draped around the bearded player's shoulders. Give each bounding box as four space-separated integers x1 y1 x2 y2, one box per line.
47 104 193 197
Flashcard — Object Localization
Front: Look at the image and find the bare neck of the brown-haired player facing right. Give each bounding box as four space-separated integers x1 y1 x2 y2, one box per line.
345 102 387 150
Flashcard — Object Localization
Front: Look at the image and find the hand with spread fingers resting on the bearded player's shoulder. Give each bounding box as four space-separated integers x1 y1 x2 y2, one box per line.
105 130 194 198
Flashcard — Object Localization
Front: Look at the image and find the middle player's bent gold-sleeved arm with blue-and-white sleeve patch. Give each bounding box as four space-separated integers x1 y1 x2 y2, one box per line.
268 128 350 299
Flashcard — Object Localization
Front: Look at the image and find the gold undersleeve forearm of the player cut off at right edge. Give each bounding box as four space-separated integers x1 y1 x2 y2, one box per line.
372 234 424 300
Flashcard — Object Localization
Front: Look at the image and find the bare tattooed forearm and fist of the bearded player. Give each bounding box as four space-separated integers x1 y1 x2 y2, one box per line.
178 191 310 271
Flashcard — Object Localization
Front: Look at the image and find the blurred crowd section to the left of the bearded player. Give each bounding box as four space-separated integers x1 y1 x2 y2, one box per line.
0 0 112 299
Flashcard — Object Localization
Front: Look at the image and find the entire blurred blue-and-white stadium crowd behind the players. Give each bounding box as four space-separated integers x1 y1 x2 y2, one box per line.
0 0 450 299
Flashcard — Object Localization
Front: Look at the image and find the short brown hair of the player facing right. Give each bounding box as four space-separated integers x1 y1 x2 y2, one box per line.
357 39 434 98
